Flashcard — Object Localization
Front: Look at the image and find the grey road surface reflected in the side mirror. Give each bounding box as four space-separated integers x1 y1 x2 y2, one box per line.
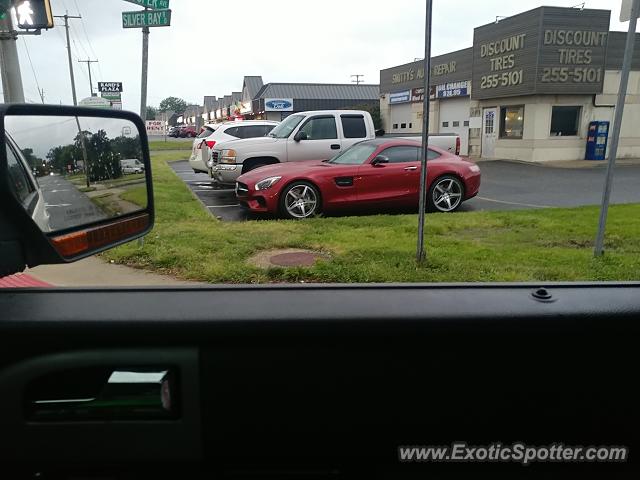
38 175 108 231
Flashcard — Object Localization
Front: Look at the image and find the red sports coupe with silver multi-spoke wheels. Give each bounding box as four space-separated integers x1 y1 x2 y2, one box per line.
236 138 480 219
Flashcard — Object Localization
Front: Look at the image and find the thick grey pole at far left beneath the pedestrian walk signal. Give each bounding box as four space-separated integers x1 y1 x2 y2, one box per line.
0 12 24 103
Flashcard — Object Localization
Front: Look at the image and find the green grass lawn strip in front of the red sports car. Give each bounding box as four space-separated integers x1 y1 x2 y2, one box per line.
105 152 640 283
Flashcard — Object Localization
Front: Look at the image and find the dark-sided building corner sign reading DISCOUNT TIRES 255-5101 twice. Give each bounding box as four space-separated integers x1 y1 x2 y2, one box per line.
471 7 611 99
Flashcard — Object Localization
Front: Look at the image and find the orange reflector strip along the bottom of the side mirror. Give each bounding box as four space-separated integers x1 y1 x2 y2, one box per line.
51 213 149 258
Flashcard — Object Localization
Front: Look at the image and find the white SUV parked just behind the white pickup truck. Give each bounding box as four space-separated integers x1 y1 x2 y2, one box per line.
189 120 279 173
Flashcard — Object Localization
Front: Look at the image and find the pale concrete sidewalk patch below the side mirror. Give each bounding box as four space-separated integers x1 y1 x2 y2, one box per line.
25 257 202 287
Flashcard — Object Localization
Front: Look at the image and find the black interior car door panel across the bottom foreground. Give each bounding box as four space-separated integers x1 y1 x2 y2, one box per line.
0 284 640 478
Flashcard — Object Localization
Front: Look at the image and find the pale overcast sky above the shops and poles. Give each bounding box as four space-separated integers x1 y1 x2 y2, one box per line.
18 0 626 111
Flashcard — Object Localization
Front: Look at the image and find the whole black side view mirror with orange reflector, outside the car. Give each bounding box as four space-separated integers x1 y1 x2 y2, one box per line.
0 105 154 271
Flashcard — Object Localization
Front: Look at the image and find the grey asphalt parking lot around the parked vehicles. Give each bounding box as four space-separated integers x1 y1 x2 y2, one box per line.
171 160 640 221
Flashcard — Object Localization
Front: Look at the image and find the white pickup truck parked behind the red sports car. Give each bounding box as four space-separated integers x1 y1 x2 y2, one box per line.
209 110 459 185
